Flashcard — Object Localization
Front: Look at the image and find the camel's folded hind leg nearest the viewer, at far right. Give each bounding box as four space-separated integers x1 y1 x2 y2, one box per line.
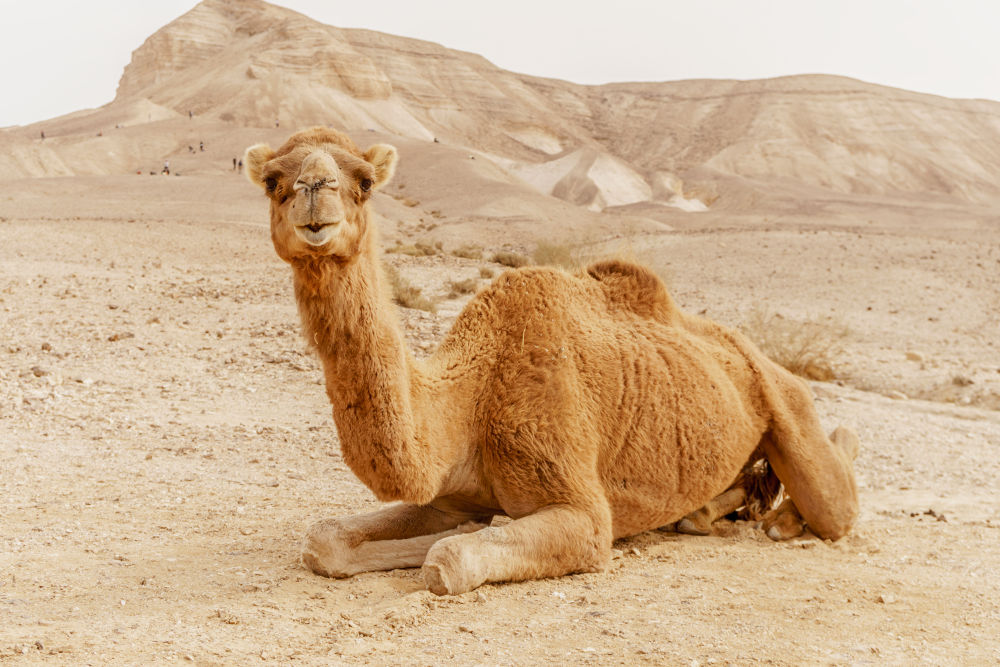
761 370 858 540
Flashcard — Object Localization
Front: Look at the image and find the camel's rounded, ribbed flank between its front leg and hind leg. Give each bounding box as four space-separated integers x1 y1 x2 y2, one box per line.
599 324 766 537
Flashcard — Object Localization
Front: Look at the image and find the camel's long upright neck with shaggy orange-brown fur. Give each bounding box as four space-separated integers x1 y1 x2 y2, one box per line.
292 222 443 504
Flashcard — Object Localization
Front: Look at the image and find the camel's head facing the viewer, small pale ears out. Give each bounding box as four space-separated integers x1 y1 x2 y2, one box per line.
244 127 396 262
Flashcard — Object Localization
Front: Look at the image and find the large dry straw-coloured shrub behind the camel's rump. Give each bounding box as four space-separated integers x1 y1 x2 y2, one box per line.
740 306 849 381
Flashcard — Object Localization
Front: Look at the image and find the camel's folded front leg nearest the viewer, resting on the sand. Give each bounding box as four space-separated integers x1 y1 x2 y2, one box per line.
423 505 611 595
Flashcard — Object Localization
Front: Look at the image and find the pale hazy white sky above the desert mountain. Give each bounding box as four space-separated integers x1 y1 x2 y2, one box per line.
0 0 1000 127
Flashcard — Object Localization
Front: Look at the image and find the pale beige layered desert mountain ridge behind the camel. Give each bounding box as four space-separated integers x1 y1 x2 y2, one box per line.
0 0 1000 219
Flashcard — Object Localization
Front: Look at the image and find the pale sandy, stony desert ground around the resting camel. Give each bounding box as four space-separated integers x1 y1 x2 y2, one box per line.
0 176 1000 665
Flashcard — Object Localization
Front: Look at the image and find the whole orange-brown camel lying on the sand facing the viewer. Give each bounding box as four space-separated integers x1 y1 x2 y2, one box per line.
246 128 858 594
